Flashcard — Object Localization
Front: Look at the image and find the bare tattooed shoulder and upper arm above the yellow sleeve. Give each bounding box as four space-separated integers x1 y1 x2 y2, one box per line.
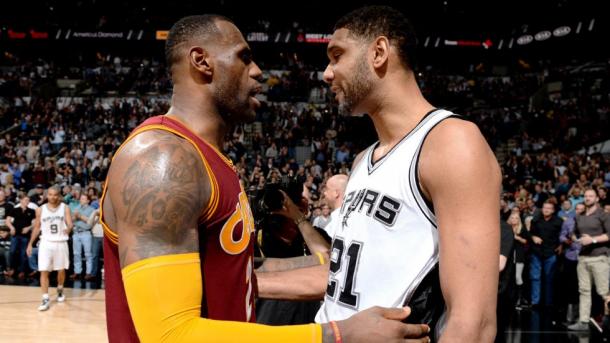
104 131 210 268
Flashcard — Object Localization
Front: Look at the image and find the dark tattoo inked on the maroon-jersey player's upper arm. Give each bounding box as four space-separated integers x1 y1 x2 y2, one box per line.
120 133 207 265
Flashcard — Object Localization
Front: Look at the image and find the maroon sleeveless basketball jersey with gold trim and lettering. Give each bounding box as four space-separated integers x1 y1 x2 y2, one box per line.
101 116 256 342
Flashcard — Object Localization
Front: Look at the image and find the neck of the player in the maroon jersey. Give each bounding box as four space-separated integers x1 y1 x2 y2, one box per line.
166 91 227 149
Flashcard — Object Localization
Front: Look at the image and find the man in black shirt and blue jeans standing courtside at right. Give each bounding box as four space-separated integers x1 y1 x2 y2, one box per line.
525 201 562 306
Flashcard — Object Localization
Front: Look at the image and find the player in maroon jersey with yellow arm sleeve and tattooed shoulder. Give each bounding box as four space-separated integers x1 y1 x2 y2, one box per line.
101 15 427 342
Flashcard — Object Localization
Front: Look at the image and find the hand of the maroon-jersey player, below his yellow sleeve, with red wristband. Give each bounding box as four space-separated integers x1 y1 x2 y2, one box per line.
337 306 430 343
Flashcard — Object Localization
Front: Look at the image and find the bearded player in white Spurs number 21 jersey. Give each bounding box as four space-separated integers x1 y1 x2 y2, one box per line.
304 6 501 342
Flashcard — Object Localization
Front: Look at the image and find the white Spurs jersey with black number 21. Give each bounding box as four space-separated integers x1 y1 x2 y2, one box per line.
316 110 454 342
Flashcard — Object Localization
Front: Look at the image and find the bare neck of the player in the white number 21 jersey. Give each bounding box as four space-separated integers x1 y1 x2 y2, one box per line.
370 79 434 147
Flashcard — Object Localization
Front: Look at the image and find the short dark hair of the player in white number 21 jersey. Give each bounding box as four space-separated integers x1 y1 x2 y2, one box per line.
334 6 417 70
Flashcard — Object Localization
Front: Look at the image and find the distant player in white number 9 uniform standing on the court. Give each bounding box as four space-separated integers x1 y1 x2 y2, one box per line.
27 186 73 311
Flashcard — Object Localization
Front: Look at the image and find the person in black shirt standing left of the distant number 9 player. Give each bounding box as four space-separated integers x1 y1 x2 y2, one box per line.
6 193 36 279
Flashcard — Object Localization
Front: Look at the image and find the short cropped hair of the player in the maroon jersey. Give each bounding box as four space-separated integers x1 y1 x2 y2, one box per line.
165 14 232 74
